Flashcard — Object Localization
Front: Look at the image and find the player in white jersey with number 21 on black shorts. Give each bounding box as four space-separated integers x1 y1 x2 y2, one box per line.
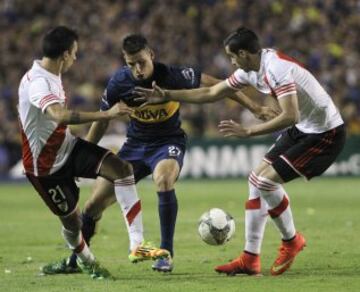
18 26 169 279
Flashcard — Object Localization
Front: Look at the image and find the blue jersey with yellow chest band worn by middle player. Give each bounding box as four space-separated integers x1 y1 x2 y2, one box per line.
101 62 201 143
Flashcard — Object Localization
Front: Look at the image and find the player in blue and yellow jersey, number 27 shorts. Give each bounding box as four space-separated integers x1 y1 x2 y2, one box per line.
50 34 273 272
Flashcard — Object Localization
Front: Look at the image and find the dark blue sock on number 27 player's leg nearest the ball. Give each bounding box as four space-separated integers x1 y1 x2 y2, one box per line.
158 190 178 256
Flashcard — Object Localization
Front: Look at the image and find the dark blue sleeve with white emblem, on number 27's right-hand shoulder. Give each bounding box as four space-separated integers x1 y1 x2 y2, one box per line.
169 67 201 89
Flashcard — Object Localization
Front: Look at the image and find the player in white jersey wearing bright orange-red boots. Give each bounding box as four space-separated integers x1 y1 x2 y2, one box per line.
134 27 346 276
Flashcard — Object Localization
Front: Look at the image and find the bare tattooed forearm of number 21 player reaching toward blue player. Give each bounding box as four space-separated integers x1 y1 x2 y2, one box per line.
45 103 134 125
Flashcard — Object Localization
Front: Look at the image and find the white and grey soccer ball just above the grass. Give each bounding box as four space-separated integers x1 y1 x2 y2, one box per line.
198 208 235 245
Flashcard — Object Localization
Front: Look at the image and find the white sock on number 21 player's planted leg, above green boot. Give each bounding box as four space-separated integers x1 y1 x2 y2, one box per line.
61 227 95 263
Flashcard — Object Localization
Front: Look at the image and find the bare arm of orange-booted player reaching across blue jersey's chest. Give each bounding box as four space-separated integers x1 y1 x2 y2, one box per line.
133 81 234 104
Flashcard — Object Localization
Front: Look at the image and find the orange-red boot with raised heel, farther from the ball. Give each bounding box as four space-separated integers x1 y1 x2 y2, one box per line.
270 233 306 276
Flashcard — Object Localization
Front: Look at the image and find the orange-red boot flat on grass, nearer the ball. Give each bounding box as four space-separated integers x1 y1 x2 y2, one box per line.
215 252 261 276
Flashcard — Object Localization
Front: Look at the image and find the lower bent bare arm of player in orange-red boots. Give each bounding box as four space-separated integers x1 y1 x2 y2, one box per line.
219 94 300 137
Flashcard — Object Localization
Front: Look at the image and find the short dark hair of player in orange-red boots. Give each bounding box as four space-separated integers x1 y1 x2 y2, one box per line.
224 26 261 54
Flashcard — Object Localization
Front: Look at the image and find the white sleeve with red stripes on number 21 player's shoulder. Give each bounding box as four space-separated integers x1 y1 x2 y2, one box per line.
29 78 63 112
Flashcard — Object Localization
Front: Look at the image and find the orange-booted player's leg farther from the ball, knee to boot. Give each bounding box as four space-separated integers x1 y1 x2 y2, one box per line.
257 165 306 276
